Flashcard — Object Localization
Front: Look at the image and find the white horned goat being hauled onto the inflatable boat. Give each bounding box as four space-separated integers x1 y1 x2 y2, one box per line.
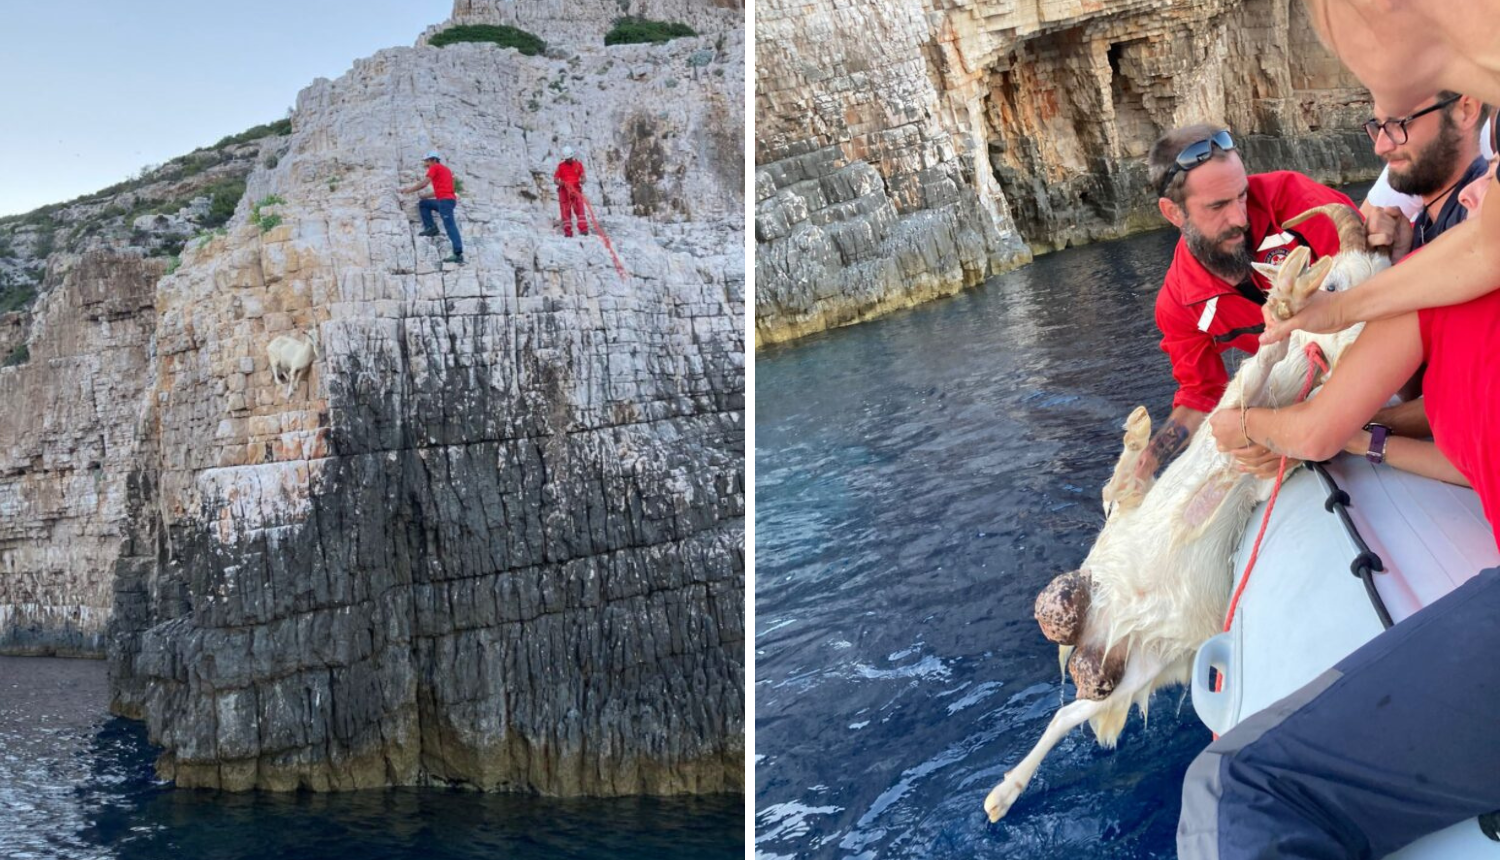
984 206 1391 821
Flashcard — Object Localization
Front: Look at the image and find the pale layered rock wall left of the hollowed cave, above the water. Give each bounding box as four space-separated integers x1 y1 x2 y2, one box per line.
755 0 1031 345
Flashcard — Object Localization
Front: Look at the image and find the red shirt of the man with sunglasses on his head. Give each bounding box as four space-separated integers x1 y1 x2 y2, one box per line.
1157 170 1355 413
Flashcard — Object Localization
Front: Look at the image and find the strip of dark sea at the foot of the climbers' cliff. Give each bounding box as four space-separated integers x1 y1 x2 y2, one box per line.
0 657 746 860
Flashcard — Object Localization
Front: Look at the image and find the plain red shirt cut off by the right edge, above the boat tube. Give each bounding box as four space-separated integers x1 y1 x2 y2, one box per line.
1416 290 1500 546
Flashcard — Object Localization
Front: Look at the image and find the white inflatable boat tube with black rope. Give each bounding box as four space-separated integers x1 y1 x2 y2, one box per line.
1193 455 1500 860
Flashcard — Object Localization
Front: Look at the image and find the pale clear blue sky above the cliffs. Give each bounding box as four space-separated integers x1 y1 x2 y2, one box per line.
0 0 453 216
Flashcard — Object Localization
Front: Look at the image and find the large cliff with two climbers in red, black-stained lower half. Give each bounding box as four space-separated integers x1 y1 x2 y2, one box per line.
0 0 746 794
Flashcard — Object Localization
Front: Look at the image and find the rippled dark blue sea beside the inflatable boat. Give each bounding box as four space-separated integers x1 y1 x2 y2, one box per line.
755 223 1209 860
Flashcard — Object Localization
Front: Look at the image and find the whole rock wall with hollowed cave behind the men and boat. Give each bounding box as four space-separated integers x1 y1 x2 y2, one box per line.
756 0 1379 344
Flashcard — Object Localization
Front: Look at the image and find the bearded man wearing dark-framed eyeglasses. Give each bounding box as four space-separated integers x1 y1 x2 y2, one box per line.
1364 90 1490 261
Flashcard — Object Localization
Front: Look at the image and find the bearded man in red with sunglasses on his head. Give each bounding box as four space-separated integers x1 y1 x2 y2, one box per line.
1136 125 1355 479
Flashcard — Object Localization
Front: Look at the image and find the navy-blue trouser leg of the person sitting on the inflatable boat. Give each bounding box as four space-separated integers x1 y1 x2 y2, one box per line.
1178 567 1500 860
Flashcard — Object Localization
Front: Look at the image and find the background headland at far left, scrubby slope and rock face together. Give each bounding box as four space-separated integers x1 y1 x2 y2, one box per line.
0 137 288 656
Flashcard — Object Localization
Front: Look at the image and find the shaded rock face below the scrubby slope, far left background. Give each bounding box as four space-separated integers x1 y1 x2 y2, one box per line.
0 251 167 656
